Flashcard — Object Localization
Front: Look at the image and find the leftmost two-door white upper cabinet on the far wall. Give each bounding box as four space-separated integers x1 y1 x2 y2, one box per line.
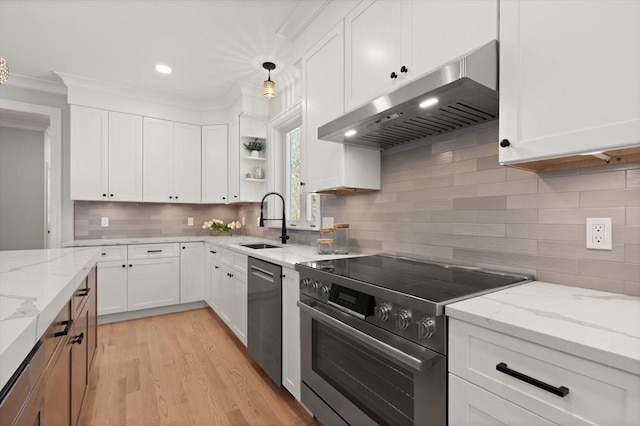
70 105 142 201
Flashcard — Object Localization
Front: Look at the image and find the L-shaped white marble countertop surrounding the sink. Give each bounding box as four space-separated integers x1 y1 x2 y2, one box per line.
63 235 364 269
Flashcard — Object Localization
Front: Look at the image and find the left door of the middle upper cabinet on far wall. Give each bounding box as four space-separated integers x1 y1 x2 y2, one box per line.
142 117 173 203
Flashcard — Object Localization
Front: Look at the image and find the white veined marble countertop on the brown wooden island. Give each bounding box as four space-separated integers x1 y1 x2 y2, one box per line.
0 247 99 388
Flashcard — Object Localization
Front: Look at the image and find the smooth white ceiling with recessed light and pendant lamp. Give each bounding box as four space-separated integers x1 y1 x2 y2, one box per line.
0 0 326 107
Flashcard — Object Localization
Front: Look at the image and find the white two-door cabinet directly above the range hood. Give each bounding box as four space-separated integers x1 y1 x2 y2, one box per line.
345 0 498 111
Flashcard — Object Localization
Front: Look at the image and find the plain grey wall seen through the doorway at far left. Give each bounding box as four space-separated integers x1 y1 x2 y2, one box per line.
0 127 45 250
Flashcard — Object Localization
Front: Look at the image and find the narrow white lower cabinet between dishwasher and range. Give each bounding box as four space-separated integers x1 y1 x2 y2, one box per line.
282 268 300 401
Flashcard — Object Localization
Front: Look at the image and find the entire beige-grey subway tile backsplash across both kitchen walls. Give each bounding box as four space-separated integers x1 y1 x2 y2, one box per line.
76 122 640 296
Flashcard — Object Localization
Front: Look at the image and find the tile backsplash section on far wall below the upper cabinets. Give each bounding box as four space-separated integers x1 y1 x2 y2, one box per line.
75 201 244 240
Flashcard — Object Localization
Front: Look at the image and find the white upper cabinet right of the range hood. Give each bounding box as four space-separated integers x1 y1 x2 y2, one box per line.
500 0 640 169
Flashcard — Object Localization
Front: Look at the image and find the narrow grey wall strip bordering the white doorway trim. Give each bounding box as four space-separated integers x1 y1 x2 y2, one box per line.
0 84 73 241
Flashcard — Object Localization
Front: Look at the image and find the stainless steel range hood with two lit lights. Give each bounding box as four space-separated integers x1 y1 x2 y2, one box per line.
318 40 498 149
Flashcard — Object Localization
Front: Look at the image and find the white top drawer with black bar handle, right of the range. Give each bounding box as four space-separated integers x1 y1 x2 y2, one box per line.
449 318 640 425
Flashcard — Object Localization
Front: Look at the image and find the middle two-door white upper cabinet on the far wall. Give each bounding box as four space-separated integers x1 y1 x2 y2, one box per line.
143 117 202 203
